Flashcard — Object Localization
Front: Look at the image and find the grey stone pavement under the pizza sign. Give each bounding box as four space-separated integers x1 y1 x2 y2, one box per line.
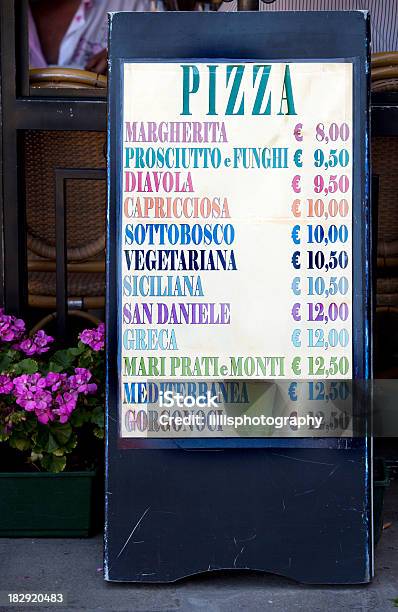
0 481 398 612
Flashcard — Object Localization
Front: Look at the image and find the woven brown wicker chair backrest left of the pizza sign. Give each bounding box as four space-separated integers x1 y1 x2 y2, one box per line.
24 130 106 261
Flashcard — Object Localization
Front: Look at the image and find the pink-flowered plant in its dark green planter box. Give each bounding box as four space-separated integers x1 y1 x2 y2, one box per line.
0 310 104 537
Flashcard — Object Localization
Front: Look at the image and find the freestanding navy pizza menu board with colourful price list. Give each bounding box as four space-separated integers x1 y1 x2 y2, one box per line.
105 12 372 583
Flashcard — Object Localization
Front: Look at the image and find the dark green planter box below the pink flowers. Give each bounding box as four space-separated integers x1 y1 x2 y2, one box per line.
0 472 102 538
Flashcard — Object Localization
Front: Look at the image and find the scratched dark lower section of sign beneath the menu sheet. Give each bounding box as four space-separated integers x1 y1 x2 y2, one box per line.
107 449 370 584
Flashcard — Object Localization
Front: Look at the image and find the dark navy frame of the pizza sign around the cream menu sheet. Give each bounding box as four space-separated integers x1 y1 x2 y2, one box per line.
105 12 372 584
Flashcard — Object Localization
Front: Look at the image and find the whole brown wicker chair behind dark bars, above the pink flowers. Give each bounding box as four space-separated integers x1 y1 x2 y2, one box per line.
23 68 106 326
